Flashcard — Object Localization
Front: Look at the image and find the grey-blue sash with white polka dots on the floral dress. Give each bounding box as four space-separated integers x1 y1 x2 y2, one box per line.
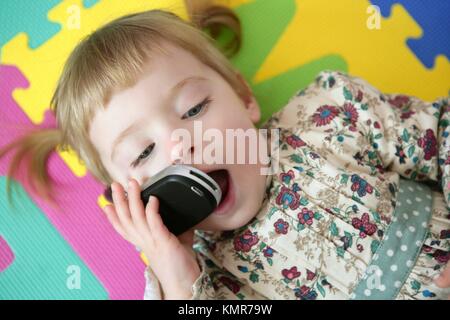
352 179 432 299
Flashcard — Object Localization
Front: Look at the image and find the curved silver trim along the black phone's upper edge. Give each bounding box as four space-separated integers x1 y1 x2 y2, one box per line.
141 164 222 205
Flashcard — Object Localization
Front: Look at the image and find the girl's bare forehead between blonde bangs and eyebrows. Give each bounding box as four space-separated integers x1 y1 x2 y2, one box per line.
89 43 211 157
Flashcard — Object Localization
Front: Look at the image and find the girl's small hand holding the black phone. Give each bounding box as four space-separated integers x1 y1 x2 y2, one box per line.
103 179 200 299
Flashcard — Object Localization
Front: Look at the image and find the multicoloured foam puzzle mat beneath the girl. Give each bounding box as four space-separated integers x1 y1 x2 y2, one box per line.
0 0 450 299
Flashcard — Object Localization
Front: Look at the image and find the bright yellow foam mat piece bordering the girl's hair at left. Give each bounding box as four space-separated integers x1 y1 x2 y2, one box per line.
0 0 188 177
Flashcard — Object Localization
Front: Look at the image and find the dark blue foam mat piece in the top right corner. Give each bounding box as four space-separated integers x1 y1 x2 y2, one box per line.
371 0 450 68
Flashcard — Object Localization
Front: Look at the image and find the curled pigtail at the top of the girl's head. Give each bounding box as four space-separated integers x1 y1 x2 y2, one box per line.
186 0 242 58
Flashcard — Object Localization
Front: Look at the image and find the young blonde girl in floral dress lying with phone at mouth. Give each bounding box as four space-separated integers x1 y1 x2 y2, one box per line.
1 10 450 300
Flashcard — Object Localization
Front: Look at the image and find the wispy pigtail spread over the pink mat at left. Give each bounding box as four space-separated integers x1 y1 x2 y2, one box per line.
0 128 62 210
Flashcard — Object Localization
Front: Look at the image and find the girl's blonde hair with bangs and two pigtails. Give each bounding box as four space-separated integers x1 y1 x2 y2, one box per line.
0 1 247 208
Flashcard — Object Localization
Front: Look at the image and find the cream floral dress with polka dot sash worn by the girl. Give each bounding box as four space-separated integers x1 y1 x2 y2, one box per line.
145 71 450 300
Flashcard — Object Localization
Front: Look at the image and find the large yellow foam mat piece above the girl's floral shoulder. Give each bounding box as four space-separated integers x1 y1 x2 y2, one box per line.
254 0 450 100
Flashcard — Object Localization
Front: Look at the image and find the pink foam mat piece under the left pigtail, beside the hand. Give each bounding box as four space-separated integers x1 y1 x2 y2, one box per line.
0 65 145 299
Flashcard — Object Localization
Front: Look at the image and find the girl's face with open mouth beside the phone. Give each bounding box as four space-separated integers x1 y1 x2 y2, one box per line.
89 43 267 230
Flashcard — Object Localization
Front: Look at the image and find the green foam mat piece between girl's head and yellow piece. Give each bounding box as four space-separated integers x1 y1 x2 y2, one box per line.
225 0 348 124
